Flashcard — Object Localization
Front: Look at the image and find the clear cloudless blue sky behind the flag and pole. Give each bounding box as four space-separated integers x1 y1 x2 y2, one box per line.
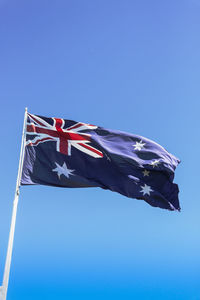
0 0 200 300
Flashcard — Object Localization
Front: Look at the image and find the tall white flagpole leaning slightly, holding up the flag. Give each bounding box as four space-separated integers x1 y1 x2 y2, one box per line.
0 108 27 300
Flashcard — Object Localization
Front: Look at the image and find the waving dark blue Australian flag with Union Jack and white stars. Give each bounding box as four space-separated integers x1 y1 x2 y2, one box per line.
21 113 180 210
